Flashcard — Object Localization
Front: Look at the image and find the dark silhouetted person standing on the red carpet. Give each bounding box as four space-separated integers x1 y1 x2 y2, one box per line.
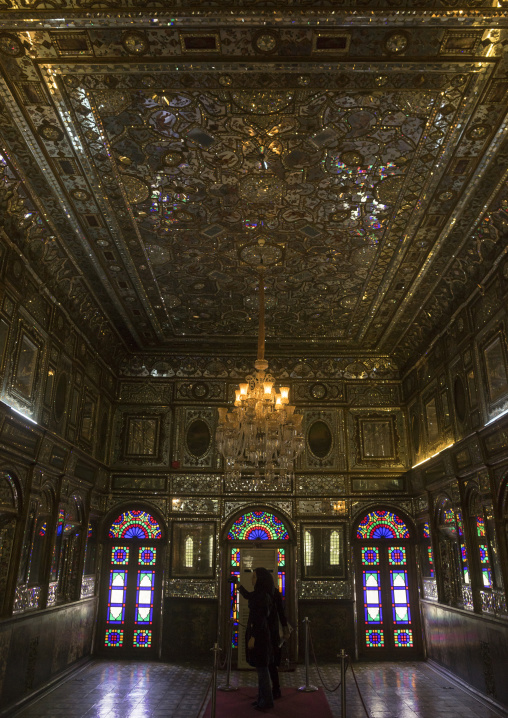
239 567 287 710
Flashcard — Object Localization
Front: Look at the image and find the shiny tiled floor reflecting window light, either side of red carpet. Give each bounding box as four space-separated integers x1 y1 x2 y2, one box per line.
9 660 502 718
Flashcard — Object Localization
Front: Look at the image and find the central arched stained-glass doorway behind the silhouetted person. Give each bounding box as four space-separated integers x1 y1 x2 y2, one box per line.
222 511 296 668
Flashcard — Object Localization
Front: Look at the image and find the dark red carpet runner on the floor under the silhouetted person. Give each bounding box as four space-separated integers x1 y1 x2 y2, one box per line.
203 686 333 718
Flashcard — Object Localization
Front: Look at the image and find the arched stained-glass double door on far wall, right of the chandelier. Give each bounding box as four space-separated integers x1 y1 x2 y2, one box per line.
354 510 422 661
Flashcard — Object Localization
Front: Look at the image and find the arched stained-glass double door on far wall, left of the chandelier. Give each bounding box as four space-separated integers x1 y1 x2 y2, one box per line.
95 510 163 658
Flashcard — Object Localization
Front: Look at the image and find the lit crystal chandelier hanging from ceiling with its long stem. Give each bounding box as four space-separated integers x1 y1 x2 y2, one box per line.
216 276 304 485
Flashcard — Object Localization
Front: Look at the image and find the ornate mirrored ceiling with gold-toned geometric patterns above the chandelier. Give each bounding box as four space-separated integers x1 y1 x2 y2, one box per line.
0 9 508 372
